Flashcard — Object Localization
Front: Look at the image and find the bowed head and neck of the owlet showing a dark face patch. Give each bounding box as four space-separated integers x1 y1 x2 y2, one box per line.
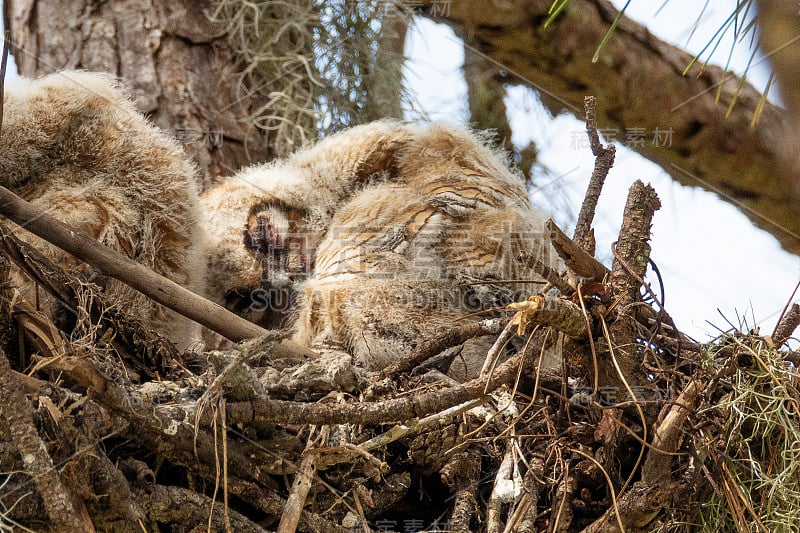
201 122 409 325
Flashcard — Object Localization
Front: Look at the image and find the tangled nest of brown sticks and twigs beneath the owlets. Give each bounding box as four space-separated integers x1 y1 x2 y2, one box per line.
0 180 800 532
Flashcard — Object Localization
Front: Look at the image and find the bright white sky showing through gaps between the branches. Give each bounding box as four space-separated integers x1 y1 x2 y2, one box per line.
406 0 800 341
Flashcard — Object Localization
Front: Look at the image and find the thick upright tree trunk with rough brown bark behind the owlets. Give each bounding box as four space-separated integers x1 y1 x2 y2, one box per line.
5 0 268 185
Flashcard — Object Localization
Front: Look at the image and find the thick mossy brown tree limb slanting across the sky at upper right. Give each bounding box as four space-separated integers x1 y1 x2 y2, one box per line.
429 0 800 253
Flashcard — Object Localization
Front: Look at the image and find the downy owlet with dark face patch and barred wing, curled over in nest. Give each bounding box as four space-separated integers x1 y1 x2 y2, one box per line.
203 121 554 376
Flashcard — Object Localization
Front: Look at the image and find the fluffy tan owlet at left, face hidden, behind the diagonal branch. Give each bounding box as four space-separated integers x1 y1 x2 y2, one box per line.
0 71 205 346
